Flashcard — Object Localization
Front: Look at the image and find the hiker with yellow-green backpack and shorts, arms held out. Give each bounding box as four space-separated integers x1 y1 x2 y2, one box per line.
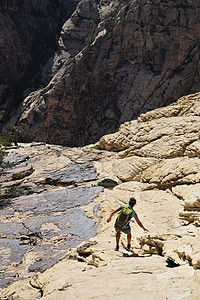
107 198 148 251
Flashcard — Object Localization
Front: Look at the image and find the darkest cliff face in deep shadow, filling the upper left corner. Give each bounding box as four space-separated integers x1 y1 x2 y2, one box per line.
0 0 78 122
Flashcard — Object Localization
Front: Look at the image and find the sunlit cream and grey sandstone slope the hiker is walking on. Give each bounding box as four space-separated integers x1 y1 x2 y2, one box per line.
0 93 200 300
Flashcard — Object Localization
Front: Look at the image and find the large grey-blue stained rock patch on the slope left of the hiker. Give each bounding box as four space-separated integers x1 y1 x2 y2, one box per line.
0 186 103 286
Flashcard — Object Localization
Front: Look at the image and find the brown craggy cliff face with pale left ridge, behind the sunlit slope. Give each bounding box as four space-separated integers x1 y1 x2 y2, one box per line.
11 0 200 145
